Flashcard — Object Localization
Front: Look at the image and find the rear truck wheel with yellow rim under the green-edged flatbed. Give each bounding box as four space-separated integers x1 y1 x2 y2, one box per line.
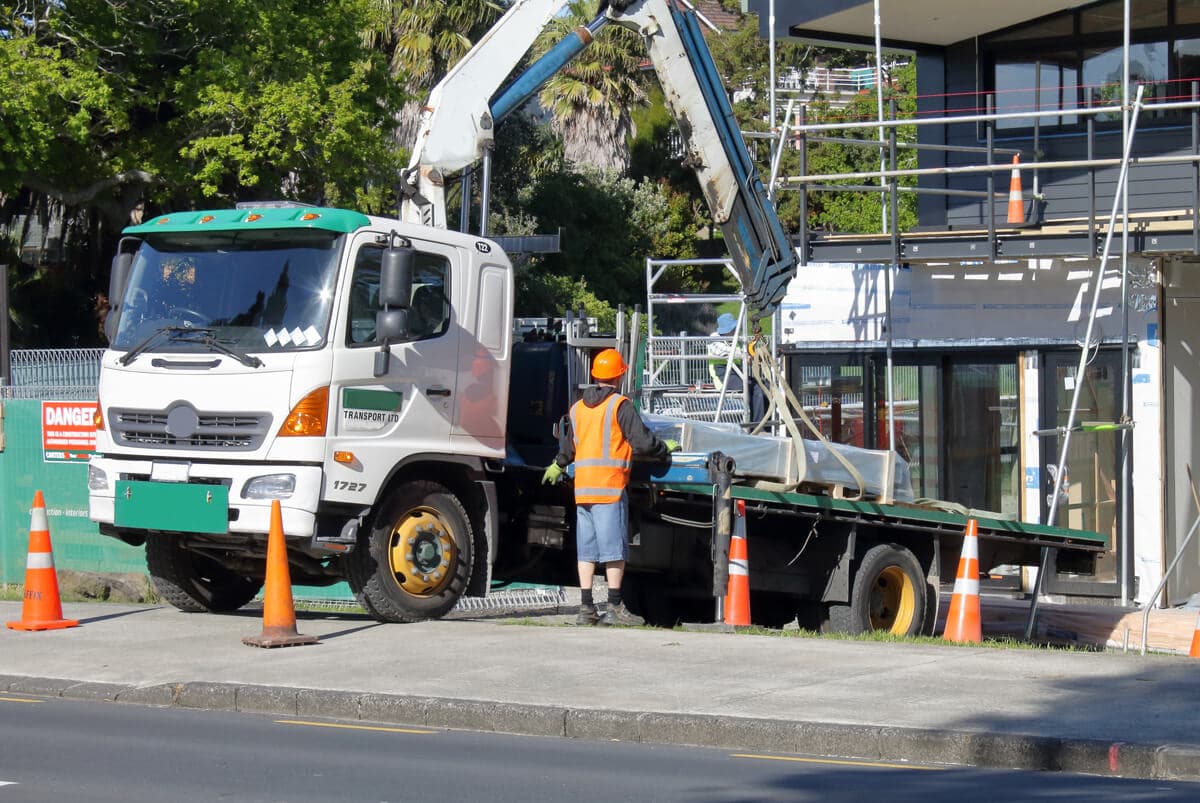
821 544 929 636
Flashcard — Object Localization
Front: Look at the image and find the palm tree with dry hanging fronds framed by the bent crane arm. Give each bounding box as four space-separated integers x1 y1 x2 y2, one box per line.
534 0 647 173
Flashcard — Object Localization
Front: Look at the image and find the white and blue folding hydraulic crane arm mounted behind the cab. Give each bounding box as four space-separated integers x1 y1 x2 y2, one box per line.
402 0 796 316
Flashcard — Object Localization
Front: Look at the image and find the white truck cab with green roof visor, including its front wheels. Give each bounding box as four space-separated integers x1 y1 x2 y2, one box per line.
89 204 512 618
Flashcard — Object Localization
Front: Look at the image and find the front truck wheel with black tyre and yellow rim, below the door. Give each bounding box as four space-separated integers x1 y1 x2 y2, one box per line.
346 481 473 622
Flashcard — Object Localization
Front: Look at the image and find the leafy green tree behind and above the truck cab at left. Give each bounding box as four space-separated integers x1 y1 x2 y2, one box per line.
0 0 404 342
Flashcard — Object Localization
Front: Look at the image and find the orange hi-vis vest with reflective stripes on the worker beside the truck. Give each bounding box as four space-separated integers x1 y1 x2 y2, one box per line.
571 394 634 504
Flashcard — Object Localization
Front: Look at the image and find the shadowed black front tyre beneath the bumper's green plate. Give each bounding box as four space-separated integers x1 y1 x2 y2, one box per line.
146 535 263 613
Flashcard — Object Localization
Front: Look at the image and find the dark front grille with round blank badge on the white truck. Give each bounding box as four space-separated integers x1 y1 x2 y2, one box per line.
108 405 271 451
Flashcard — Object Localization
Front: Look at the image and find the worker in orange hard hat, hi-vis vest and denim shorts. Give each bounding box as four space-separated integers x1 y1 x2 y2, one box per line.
541 348 679 625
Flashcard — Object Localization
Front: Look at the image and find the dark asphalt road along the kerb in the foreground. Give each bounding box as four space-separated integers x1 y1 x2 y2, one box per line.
0 694 1200 803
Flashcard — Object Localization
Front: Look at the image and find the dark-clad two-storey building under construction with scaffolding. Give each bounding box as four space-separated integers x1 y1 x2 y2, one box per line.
705 0 1200 605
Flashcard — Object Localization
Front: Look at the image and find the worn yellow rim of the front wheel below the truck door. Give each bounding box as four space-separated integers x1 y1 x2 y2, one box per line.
388 508 458 597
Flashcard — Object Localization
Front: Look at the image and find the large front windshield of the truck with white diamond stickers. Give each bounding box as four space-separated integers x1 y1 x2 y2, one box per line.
112 229 344 352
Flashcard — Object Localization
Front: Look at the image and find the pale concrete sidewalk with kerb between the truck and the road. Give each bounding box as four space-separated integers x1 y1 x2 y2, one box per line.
0 603 1200 780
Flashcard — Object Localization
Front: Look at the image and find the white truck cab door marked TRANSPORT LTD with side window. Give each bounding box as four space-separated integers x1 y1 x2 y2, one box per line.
326 232 464 492
